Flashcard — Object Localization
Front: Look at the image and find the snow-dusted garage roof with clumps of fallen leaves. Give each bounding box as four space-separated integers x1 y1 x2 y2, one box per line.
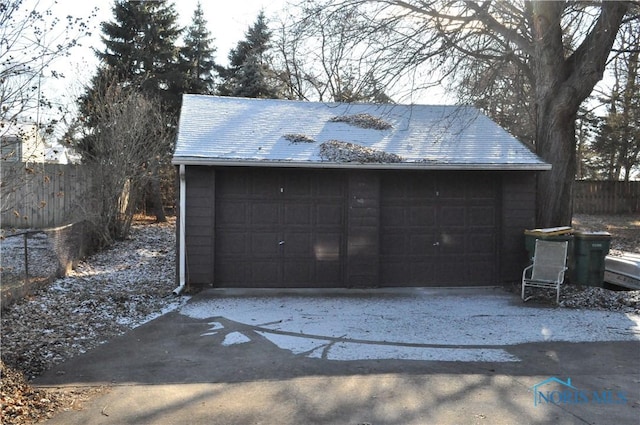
173 94 551 170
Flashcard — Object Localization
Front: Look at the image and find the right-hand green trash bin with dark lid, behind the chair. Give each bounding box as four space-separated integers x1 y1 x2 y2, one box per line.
573 231 611 287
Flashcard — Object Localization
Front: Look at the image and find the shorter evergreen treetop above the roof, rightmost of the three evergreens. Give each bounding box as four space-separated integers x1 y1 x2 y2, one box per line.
218 12 279 98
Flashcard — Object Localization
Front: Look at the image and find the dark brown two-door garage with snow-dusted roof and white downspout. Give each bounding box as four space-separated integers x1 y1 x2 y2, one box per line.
173 95 550 288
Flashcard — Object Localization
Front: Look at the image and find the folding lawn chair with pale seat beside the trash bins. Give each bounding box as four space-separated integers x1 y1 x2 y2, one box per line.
522 239 569 304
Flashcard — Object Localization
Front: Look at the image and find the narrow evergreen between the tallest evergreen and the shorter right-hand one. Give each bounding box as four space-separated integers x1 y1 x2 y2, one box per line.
180 2 216 94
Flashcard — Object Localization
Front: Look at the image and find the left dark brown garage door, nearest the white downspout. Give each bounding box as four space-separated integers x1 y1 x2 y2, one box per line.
214 168 345 288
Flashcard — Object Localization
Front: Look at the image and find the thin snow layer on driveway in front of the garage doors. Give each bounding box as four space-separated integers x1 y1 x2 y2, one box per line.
180 289 640 361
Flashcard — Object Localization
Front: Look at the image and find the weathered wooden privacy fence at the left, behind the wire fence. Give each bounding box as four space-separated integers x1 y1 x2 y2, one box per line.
0 162 90 229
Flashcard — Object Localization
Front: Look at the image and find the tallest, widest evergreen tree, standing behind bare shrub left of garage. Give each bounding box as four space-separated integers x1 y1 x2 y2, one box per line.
78 0 184 221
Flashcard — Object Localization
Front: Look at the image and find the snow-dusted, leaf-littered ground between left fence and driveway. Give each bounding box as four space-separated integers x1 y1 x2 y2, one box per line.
0 220 189 378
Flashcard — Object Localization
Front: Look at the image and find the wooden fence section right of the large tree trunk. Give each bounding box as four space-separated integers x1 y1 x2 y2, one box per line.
573 180 640 214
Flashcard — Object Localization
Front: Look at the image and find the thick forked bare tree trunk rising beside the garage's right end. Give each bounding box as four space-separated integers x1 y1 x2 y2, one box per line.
532 1 628 227
